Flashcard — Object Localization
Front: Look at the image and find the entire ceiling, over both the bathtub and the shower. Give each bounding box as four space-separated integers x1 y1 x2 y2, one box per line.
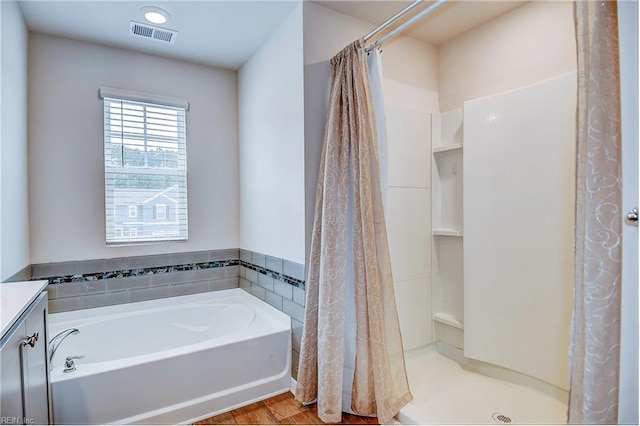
20 0 523 69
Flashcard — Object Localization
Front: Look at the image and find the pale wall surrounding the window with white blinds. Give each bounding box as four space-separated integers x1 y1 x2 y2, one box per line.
29 34 239 263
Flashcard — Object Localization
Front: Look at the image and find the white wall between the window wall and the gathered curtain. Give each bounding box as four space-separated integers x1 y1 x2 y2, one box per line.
238 5 304 263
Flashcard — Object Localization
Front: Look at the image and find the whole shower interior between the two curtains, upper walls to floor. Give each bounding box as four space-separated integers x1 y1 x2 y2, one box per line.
370 3 577 424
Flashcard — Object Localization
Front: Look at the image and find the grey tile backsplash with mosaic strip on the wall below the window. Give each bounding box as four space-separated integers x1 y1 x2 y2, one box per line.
26 249 239 313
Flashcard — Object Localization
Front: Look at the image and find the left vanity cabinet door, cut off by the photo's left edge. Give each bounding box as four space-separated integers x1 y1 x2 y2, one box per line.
0 324 25 418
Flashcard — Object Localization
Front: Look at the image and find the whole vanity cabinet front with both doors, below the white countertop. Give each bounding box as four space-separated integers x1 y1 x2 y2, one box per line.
0 292 52 424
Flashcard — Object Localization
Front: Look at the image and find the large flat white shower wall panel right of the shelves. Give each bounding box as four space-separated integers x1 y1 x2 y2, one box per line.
464 73 576 389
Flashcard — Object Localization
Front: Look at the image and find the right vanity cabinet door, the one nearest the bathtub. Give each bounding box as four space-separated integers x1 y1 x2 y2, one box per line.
22 297 49 425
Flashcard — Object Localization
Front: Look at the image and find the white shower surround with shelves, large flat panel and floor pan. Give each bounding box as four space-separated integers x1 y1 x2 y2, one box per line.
400 73 576 423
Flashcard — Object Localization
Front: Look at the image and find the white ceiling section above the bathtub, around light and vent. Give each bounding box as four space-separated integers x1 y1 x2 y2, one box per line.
19 0 298 69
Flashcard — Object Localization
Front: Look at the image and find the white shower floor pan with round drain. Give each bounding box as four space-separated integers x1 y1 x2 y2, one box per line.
397 347 567 424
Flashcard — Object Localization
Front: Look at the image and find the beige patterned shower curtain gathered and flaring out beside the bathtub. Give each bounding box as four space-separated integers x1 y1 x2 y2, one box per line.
296 40 412 423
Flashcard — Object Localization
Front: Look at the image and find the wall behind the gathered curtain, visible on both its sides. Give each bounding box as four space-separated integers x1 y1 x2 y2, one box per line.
304 3 438 349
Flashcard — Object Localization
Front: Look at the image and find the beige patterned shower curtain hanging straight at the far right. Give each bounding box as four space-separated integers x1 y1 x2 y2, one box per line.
569 0 622 424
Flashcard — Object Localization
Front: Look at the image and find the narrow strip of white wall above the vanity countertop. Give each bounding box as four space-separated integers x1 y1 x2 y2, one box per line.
0 1 29 280
